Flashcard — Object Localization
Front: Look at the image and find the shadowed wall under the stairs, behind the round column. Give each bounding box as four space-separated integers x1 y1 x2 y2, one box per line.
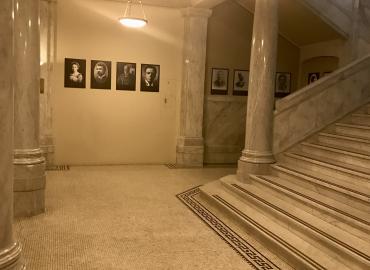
203 1 299 163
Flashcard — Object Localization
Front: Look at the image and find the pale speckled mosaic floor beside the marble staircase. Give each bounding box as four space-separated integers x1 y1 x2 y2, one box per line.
15 166 284 270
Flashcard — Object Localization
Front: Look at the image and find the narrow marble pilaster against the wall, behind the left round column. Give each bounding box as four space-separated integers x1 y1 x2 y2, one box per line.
40 0 57 168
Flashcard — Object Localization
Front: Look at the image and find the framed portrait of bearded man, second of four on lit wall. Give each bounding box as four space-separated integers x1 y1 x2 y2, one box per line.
90 60 112 89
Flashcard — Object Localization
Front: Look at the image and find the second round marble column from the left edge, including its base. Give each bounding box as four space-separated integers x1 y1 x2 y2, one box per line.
14 0 45 216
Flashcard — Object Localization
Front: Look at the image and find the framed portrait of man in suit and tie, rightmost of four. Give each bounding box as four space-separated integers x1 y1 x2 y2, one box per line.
140 64 160 92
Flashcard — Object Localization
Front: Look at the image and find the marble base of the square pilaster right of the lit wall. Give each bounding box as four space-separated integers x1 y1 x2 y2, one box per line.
176 137 204 167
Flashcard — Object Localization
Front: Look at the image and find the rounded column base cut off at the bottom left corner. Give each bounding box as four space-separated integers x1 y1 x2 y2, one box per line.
0 243 26 270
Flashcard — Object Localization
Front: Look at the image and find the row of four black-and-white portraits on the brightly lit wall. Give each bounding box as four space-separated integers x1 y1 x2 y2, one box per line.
64 58 160 92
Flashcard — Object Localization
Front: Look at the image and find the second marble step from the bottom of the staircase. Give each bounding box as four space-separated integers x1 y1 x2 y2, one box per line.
221 176 370 269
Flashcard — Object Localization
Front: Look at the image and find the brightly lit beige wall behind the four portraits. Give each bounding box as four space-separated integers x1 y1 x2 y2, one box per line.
53 0 183 164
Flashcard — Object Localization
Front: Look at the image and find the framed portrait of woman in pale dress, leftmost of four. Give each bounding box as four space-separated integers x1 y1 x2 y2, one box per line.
64 58 86 88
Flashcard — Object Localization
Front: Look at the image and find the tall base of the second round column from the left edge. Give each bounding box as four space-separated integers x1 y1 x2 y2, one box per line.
14 149 46 217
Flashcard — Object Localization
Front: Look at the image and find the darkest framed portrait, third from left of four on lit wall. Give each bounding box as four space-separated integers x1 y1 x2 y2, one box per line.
116 62 136 91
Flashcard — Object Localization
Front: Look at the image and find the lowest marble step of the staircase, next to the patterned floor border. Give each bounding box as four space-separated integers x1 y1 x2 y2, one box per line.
200 181 351 270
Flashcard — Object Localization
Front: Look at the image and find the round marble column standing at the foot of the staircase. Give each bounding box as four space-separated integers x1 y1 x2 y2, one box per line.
238 0 278 180
